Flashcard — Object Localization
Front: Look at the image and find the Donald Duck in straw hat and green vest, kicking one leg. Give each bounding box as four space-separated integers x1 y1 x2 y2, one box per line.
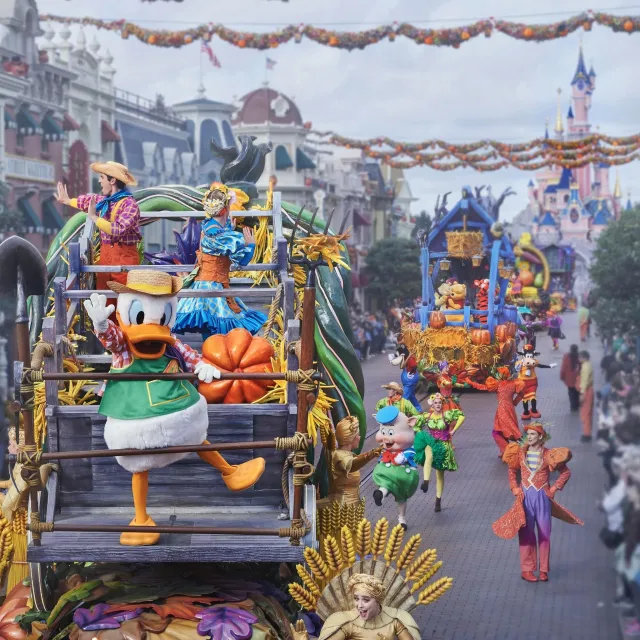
84 269 265 546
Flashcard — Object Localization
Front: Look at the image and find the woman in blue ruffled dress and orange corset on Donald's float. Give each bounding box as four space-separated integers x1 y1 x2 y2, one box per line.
175 183 267 339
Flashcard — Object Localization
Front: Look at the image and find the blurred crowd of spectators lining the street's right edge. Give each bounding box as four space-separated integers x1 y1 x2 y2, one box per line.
596 338 640 637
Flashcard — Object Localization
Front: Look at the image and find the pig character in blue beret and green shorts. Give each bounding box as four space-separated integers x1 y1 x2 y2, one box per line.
373 406 420 529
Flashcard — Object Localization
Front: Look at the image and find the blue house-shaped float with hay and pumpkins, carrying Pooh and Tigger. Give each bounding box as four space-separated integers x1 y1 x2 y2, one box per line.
401 187 518 384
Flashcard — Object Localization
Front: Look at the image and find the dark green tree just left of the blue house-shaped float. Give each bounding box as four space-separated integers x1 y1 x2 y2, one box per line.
365 238 422 306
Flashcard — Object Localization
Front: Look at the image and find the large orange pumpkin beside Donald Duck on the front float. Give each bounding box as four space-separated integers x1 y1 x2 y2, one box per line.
198 328 273 404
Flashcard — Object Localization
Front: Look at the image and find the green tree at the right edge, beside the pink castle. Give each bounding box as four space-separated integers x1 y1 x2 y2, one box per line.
591 208 640 337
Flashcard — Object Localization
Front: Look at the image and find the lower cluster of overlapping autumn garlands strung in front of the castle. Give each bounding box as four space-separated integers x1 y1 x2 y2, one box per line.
311 130 640 171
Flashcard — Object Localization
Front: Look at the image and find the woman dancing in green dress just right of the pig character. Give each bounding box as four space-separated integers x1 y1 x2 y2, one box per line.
414 393 464 511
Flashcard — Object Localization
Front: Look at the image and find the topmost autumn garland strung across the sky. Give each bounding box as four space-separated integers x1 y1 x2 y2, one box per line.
40 11 640 51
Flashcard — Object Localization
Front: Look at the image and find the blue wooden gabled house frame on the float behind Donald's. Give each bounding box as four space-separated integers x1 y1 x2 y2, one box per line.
419 186 518 341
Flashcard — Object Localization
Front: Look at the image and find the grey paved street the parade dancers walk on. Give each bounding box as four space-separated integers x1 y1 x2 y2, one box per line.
362 313 619 640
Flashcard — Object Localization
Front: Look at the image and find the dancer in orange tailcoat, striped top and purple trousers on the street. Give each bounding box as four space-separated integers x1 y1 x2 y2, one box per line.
492 422 584 582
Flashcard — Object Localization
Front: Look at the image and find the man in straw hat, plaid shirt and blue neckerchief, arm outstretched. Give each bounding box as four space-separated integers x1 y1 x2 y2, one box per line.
56 160 142 289
